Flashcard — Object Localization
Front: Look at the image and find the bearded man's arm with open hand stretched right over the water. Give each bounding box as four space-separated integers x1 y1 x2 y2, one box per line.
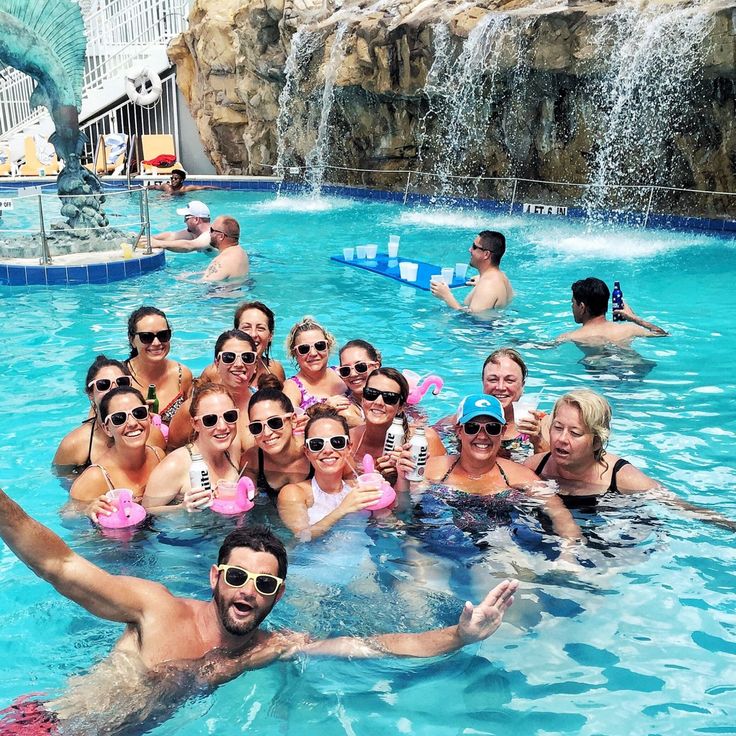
288 580 519 659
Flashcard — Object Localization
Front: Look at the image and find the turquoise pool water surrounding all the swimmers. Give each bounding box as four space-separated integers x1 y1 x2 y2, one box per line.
0 192 736 736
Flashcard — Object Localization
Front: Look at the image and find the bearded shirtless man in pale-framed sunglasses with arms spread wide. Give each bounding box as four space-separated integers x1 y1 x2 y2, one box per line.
0 491 518 734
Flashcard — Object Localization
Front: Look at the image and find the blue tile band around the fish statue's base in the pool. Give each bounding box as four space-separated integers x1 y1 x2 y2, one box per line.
0 251 166 286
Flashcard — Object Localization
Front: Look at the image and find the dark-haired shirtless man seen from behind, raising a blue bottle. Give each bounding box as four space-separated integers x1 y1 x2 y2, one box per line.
555 276 668 348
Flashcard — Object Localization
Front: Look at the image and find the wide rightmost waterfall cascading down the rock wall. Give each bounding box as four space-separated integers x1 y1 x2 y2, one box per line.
585 3 713 214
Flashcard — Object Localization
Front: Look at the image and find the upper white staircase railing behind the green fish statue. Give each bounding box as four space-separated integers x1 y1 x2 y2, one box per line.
0 0 189 139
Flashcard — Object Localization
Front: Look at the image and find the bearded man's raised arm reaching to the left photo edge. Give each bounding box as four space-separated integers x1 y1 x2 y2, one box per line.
0 490 171 623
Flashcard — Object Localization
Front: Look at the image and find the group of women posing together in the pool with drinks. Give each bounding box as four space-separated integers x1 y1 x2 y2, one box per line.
54 301 732 540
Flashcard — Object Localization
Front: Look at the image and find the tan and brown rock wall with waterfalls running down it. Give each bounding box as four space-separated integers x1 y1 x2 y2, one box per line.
169 0 736 204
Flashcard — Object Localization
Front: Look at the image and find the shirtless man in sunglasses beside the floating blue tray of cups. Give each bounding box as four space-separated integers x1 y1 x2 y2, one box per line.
430 230 514 314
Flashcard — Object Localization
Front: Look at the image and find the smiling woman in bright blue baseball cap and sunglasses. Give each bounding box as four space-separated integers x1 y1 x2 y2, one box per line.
425 394 580 541
